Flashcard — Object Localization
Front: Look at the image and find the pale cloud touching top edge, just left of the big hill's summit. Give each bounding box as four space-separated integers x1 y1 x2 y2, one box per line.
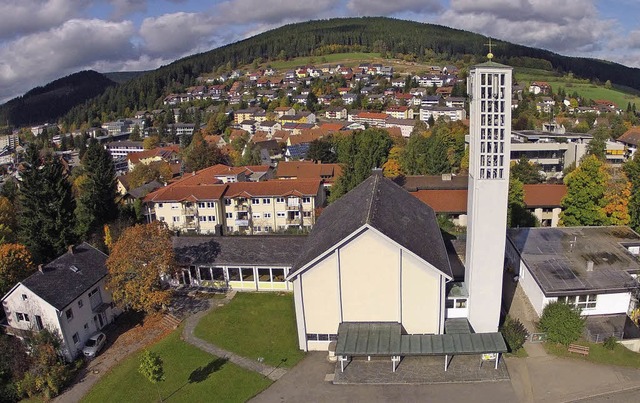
216 0 340 25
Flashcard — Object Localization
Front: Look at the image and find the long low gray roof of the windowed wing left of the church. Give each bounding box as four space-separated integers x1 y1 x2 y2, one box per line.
173 235 306 267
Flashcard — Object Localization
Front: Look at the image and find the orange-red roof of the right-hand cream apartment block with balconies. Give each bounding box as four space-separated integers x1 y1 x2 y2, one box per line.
224 180 322 197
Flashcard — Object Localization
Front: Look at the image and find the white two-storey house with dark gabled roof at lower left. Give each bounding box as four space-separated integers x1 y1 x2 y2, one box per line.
2 242 119 361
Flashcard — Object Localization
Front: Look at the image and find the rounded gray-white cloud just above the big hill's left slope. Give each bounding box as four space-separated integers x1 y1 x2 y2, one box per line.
140 12 220 58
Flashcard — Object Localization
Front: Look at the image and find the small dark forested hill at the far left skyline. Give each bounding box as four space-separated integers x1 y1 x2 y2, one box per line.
0 70 116 126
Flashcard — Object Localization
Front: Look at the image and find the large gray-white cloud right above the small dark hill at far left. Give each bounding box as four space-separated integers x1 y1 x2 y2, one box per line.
0 19 138 100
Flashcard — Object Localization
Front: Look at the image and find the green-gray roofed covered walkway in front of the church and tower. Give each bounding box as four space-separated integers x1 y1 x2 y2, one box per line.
336 319 507 372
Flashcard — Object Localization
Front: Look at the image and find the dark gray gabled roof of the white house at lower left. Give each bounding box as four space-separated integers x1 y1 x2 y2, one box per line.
22 242 107 310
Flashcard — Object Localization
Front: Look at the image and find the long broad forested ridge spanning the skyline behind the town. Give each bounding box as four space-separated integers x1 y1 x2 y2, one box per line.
13 17 640 123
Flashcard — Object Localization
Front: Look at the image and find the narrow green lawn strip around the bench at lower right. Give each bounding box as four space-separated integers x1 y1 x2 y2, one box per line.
544 342 640 368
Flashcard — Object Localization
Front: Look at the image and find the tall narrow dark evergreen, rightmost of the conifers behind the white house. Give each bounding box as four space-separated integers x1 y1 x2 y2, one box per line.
76 140 118 237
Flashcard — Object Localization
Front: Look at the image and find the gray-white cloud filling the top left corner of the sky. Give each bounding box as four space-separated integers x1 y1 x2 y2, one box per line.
0 0 89 40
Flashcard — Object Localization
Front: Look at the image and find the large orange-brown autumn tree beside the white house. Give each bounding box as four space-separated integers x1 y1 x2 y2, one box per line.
107 222 174 313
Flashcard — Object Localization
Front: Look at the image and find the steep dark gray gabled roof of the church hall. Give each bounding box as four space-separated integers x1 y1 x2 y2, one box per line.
294 171 452 277
